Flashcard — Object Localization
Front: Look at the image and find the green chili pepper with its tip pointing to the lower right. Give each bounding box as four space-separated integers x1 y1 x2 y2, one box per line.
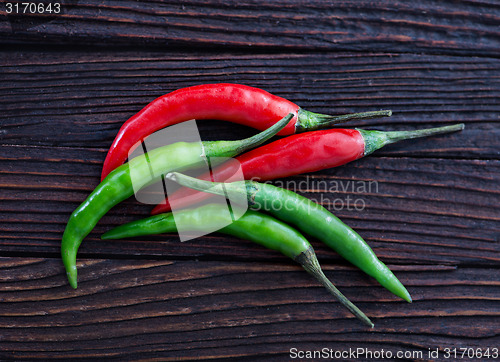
166 172 411 303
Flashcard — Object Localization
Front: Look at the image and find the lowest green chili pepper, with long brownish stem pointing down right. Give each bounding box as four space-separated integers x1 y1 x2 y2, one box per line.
101 204 373 327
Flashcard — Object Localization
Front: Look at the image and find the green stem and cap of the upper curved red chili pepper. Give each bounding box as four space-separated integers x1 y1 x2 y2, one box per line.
295 108 392 133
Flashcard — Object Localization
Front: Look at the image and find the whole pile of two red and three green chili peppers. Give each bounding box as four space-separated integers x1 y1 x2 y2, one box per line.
61 83 464 327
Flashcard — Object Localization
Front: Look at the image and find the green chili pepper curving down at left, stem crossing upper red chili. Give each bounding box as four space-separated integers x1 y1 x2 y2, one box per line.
61 113 293 288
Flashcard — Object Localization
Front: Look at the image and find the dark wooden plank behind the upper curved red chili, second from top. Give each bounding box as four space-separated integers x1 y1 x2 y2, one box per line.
0 51 500 157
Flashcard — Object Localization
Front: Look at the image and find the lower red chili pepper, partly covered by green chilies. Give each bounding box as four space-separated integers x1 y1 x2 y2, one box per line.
151 124 464 215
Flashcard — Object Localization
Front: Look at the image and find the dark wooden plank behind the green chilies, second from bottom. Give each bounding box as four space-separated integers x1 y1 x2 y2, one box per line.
0 141 500 265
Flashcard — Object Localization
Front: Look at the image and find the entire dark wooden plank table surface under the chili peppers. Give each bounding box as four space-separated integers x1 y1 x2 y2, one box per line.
0 0 500 361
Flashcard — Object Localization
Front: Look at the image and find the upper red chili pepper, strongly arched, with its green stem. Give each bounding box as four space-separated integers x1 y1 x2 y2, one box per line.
101 83 391 180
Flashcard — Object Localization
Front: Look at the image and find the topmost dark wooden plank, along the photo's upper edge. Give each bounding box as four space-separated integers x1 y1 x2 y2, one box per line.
0 0 500 57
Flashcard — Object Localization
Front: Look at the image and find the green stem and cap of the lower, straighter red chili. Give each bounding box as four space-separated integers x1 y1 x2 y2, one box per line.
357 123 465 156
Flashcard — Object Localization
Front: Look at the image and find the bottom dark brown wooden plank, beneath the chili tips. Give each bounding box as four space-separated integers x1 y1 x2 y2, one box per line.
0 258 500 359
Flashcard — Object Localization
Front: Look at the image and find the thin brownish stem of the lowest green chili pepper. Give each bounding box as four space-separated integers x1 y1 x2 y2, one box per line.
295 248 374 328
